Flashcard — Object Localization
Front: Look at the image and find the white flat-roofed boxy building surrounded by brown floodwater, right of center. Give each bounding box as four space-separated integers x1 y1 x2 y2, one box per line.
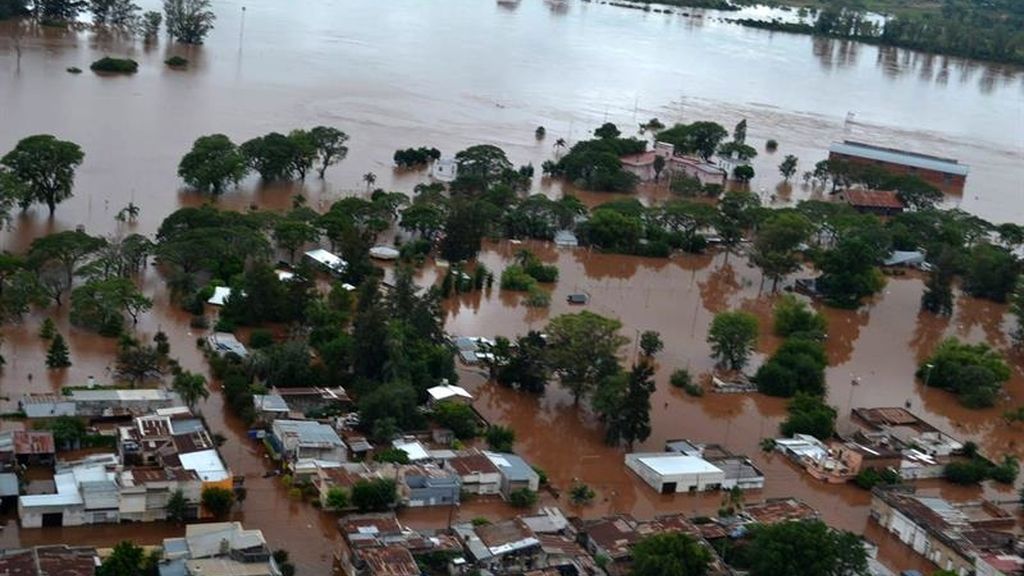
626 452 725 494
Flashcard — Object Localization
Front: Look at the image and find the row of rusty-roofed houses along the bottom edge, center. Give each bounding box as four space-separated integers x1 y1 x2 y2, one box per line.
336 499 818 576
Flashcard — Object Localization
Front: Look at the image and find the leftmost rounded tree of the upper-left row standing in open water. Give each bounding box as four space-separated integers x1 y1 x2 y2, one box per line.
178 134 249 195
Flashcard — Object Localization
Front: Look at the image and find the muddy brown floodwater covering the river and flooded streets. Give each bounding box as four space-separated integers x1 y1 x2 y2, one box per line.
0 0 1024 574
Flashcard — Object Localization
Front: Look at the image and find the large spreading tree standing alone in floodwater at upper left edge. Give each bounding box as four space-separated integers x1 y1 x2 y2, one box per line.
0 134 85 216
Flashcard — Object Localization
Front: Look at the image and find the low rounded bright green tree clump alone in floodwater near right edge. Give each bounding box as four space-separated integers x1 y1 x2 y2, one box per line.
918 338 1011 408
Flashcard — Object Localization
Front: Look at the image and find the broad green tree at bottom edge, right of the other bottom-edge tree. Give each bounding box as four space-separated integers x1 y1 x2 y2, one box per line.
748 521 870 576
